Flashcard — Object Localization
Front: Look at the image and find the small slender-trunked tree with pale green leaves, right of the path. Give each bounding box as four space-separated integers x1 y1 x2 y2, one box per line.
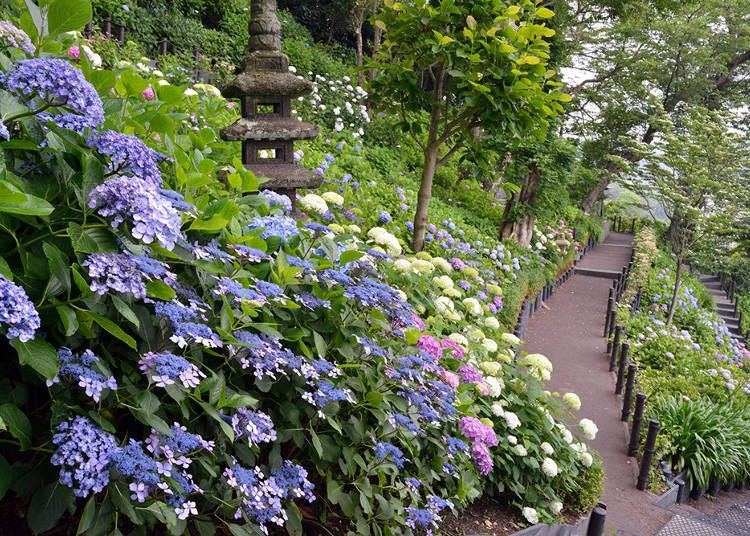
626 103 750 323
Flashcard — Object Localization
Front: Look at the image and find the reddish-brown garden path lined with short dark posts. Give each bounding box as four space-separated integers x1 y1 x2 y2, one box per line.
524 233 673 536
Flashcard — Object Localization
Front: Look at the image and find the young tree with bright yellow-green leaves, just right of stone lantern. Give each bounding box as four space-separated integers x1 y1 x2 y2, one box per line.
370 0 569 251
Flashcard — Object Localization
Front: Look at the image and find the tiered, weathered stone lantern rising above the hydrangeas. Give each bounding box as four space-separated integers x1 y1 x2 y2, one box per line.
220 0 323 211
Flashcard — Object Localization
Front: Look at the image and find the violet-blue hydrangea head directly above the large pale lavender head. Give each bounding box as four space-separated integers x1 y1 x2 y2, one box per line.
86 130 166 187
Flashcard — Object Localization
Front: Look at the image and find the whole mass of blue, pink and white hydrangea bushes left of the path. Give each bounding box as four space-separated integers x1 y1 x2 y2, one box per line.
0 4 601 535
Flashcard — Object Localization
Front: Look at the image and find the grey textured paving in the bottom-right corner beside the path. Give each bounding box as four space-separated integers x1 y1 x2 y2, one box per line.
657 503 750 536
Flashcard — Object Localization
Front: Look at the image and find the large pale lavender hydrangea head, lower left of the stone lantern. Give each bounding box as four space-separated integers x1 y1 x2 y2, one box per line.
89 175 184 250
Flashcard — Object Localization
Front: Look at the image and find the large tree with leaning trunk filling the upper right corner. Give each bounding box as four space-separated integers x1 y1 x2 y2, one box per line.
568 0 750 214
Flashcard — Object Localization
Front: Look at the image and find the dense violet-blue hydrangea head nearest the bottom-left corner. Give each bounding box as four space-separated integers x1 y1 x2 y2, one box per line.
51 416 117 497
